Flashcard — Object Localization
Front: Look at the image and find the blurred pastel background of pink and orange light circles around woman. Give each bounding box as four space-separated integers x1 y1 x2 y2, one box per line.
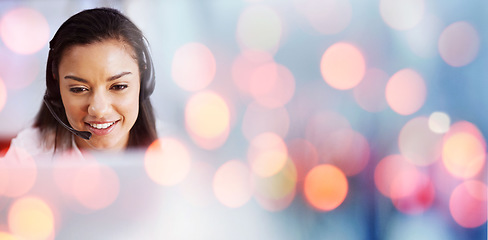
0 0 488 239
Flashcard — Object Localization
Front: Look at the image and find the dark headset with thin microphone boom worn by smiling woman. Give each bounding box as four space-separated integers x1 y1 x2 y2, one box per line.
43 37 156 140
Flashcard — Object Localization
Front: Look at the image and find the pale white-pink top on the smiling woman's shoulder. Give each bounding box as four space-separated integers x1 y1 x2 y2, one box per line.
2 127 84 163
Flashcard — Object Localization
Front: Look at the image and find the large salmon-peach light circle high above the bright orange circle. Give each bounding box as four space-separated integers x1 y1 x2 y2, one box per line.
320 42 366 90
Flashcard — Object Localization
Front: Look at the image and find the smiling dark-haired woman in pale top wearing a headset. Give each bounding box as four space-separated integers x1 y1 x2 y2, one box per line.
2 8 157 157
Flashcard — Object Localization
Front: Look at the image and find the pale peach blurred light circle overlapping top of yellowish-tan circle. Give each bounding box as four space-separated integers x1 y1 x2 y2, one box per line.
247 132 288 177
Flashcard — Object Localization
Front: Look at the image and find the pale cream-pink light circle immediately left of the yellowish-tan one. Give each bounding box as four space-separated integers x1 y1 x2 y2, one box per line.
213 160 252 208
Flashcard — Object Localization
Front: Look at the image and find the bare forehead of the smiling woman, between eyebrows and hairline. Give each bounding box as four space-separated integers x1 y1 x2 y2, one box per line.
59 39 138 71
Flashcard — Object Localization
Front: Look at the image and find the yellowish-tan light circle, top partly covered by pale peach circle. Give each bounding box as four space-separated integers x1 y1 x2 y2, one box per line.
252 159 297 211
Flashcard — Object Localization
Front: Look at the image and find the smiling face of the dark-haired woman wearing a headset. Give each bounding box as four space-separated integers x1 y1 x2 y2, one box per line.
59 40 140 150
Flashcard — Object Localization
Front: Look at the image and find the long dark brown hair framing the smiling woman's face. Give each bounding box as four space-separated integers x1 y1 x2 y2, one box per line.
34 8 157 149
